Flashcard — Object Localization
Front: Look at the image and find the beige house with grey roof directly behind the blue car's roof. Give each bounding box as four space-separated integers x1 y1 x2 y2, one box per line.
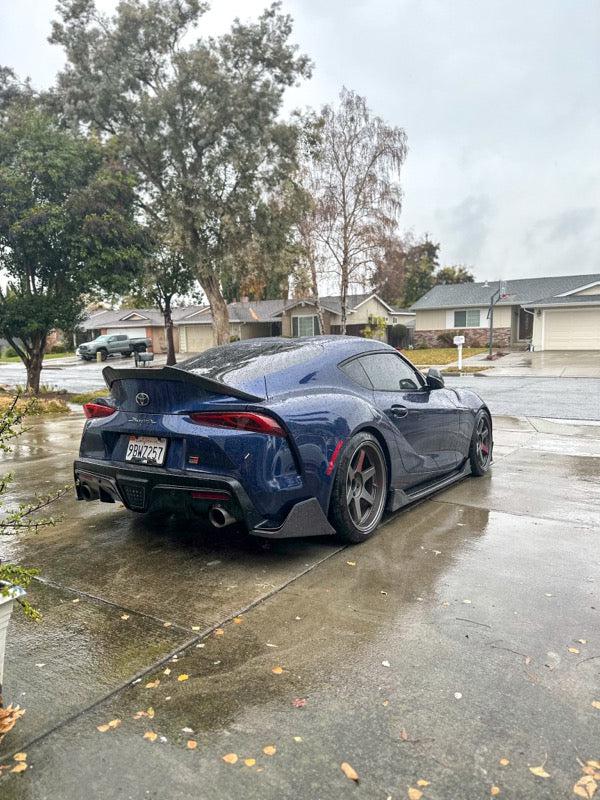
177 293 415 353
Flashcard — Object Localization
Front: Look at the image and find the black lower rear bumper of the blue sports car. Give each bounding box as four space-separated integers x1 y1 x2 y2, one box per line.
73 459 335 539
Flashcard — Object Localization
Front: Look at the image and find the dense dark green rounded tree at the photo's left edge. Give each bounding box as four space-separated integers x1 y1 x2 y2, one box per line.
0 97 144 394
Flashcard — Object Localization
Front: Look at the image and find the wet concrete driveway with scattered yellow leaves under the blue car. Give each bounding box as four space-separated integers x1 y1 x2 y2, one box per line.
0 417 600 800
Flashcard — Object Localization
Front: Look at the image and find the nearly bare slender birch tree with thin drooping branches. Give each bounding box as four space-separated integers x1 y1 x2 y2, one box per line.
309 88 407 333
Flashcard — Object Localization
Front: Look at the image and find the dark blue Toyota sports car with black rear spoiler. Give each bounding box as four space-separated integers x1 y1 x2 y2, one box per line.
75 336 493 542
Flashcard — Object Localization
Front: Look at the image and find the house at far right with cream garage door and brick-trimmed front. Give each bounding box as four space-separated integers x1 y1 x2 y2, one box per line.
410 274 600 350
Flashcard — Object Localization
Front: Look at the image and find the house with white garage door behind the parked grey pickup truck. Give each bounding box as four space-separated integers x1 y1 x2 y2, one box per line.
79 308 189 353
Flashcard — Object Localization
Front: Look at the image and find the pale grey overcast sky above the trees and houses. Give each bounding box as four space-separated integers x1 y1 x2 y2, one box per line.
0 0 600 279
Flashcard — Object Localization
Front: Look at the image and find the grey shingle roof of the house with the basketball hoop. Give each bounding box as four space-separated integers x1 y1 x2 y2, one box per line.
411 273 600 311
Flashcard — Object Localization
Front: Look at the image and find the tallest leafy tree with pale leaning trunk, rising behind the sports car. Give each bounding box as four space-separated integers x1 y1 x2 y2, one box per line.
51 0 310 343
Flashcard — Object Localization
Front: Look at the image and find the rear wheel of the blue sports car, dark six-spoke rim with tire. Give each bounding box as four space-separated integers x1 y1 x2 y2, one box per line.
329 433 388 544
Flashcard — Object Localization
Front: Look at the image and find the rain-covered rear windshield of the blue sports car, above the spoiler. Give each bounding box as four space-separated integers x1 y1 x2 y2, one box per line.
177 339 323 392
